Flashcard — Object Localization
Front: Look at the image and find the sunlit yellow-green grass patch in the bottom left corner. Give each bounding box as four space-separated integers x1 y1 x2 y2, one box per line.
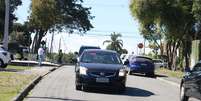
0 72 36 101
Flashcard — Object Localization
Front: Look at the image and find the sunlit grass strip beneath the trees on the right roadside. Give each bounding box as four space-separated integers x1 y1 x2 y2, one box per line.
156 68 184 78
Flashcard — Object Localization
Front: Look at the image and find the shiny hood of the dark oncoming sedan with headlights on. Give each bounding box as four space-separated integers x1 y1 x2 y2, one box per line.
80 63 124 71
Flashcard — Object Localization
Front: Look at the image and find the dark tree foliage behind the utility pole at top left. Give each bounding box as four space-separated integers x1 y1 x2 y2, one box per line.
0 0 22 40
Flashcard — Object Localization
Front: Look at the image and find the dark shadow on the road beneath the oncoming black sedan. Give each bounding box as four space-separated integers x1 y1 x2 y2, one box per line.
84 87 155 97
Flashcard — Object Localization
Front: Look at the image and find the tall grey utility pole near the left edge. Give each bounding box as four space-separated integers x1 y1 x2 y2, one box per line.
3 0 10 50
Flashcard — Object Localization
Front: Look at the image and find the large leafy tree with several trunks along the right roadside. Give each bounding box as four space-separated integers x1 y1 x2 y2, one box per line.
130 0 195 70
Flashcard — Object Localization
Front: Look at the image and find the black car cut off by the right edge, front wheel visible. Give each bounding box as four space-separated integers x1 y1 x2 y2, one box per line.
180 61 201 101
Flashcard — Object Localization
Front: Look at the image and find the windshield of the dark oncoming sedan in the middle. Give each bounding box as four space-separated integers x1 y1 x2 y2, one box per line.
81 51 121 64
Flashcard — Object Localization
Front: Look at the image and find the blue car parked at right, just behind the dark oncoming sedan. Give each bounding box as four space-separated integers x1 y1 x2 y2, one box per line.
125 56 155 76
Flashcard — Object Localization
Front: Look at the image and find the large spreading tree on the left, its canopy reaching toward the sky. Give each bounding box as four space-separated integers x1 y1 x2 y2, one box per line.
29 0 93 52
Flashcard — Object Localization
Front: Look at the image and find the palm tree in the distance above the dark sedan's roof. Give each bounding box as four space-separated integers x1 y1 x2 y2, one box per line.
103 32 123 54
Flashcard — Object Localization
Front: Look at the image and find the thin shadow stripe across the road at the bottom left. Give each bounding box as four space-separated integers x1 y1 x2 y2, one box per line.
26 97 86 101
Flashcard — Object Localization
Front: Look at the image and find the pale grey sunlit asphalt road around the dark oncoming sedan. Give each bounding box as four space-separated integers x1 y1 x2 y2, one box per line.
25 66 198 101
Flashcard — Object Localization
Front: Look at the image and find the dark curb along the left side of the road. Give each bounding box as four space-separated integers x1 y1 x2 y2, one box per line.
12 67 59 101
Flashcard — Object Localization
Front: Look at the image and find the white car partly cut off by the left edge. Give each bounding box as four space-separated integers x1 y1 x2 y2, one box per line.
0 47 11 68
